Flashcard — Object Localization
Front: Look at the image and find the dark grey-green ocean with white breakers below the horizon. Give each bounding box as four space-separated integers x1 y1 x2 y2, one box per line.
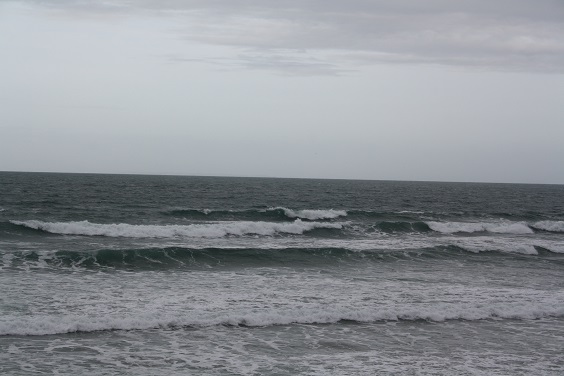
0 172 564 375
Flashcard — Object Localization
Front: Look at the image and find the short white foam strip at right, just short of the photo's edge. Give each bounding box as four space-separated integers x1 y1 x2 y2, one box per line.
426 221 533 234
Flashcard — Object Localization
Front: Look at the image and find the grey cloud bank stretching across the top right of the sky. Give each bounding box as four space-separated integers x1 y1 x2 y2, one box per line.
17 0 564 74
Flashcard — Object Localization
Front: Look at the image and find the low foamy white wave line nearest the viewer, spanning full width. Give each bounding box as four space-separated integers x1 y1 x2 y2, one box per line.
0 303 564 336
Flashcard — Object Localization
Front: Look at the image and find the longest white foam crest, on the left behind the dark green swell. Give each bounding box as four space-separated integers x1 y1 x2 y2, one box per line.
10 219 344 238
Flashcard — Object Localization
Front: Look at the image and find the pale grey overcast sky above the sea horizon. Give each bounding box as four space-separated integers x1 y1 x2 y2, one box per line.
0 0 564 184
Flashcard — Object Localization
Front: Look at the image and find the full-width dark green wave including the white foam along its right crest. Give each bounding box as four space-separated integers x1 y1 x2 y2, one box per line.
4 242 564 271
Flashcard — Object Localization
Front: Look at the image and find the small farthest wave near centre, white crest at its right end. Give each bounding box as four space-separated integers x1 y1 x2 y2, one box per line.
165 207 347 221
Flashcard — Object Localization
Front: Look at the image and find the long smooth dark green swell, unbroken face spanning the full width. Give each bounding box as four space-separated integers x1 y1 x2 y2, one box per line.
0 245 564 270
